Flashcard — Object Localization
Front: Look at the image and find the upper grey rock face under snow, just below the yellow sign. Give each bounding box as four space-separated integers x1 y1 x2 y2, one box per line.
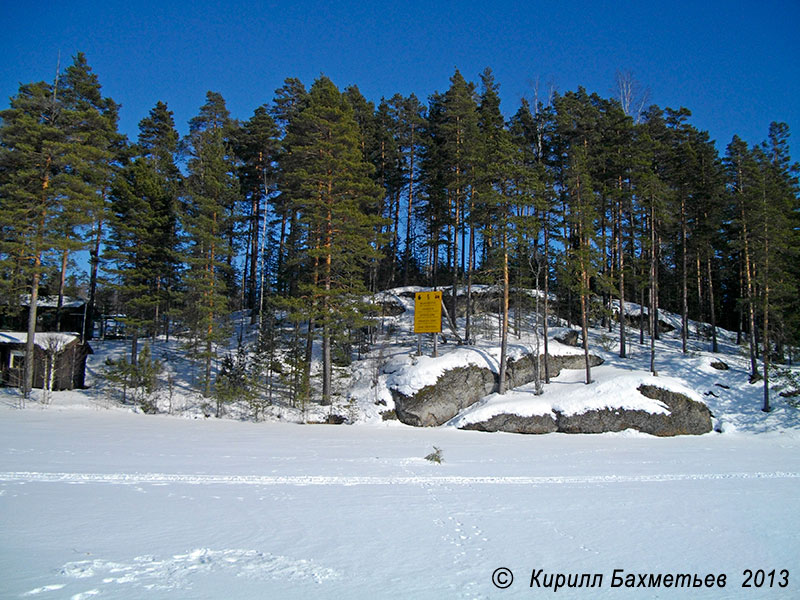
391 354 603 426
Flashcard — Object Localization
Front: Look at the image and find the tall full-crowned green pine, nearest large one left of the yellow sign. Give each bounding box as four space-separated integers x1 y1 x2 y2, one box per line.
281 77 379 404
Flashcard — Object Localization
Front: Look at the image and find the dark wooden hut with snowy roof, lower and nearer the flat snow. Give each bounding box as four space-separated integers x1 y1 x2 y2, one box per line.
0 331 93 390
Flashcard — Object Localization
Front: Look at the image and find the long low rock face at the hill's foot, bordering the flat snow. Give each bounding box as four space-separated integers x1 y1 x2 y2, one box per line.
462 385 711 437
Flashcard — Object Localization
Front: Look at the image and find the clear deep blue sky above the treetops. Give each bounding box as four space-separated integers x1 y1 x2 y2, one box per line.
0 0 800 160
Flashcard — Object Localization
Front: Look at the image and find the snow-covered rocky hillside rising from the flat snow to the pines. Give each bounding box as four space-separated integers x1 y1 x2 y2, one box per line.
0 287 800 434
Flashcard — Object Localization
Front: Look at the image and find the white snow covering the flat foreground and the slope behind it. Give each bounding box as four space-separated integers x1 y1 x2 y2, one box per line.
0 290 800 600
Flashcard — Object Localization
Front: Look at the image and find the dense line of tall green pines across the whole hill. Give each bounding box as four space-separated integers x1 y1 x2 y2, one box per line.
0 54 800 410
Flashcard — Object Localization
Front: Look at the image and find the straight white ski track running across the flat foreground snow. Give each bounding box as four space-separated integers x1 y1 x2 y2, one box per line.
0 471 800 486
